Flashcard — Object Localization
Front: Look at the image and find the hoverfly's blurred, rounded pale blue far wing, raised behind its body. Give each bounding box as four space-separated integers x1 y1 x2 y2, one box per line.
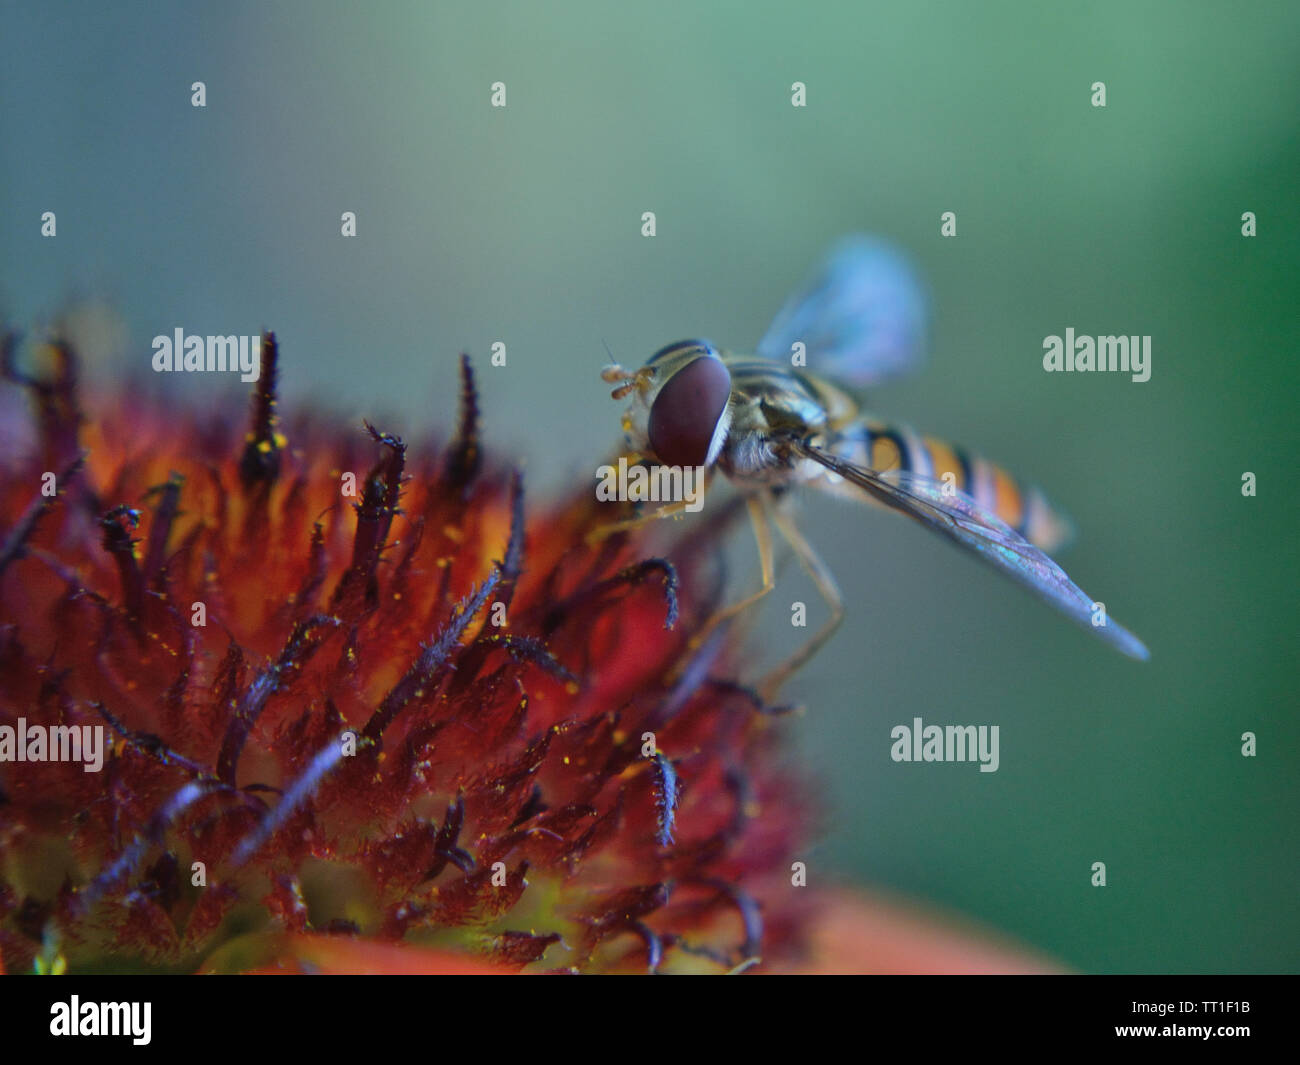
758 235 926 388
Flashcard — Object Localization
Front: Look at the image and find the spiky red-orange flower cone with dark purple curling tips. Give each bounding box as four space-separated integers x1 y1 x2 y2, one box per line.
0 334 807 971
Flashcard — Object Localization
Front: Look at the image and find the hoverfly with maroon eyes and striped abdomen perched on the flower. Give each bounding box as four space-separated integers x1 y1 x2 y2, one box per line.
602 237 1149 698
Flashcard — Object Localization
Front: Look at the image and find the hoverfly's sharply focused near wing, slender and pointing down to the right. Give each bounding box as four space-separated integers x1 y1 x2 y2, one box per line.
793 441 1151 661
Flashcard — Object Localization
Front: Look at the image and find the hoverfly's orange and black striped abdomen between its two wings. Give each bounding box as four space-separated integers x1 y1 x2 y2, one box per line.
828 417 1074 554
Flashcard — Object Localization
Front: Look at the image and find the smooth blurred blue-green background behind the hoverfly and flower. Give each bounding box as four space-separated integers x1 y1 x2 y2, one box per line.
0 0 1300 971
